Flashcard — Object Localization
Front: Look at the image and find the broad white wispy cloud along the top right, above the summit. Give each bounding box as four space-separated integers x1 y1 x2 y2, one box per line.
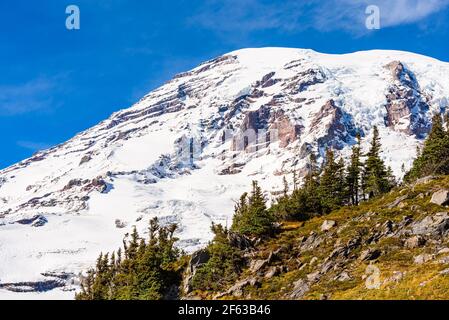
190 0 449 37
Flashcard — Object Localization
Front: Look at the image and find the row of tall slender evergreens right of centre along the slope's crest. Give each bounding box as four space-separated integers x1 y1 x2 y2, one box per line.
271 127 396 220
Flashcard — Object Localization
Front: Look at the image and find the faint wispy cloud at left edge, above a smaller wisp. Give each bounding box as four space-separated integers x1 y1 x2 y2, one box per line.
0 77 57 116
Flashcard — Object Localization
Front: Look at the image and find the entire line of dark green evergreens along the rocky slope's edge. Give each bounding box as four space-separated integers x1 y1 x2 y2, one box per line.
76 115 449 300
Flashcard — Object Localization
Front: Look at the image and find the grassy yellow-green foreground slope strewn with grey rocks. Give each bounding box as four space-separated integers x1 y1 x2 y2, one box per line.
187 176 449 300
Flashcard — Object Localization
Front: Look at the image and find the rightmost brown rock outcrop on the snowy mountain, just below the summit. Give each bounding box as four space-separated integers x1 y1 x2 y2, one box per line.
385 61 430 137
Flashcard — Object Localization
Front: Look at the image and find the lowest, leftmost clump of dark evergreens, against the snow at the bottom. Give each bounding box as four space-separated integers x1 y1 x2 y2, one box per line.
76 219 182 300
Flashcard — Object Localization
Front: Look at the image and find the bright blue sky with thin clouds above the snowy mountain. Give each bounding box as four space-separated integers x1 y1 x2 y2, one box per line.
0 0 449 168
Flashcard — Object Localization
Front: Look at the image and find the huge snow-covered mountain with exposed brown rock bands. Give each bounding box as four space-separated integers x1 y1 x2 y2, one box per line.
0 48 449 299
